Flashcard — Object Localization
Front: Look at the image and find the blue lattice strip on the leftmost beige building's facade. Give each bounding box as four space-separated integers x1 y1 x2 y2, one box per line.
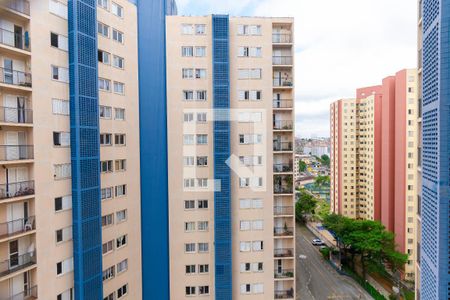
68 0 103 300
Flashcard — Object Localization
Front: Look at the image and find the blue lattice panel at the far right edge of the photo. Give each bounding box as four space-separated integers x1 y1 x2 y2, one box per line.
420 0 450 300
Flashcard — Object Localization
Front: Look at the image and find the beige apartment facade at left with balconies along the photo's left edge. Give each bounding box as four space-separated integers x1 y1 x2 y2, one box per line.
0 0 141 300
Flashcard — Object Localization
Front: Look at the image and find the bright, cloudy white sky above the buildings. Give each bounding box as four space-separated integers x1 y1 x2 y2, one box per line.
177 0 417 138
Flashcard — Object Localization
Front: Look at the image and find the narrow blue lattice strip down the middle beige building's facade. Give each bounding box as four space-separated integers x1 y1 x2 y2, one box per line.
212 15 232 300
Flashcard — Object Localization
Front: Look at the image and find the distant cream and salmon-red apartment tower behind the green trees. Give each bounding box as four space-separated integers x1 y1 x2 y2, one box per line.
330 69 420 280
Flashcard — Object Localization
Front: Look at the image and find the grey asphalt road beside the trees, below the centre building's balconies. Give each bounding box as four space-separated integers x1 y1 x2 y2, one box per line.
296 225 372 300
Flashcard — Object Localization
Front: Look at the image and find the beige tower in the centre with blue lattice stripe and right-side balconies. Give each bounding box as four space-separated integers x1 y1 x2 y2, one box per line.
166 15 295 300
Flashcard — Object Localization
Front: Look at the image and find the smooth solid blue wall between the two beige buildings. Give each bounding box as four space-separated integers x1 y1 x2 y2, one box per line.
137 0 176 300
